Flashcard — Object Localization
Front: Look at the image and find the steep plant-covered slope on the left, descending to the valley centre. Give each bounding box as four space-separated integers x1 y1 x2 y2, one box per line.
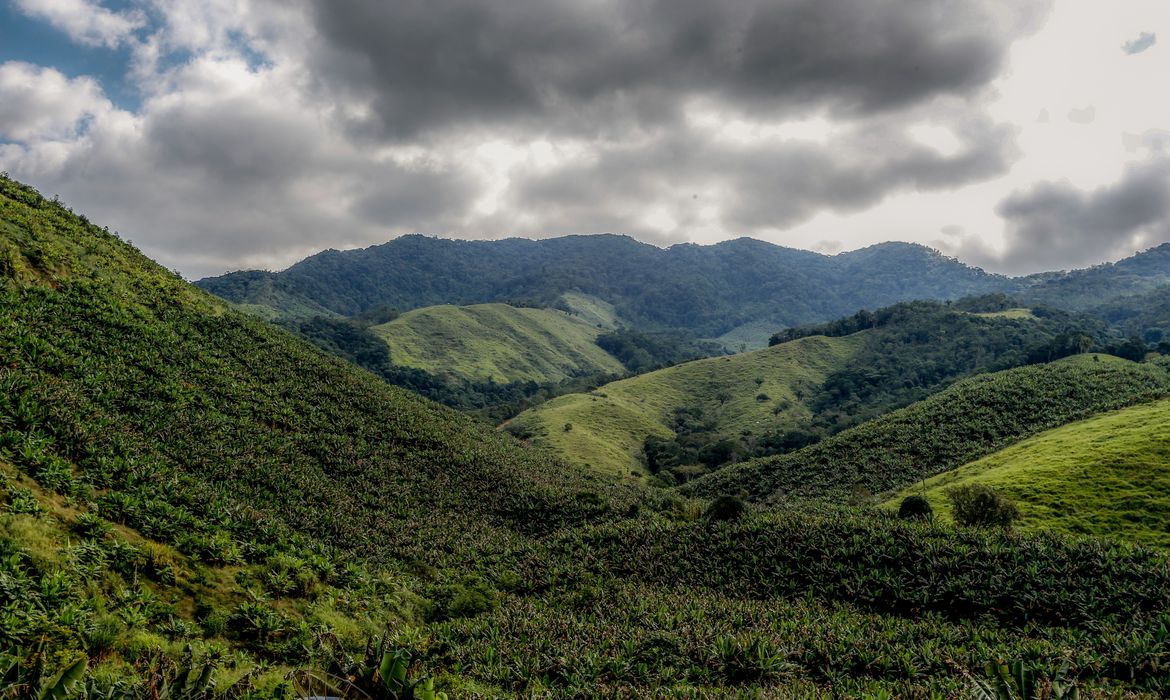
0 178 634 675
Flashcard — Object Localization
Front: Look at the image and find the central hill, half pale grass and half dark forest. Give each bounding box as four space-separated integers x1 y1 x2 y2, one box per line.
508 296 1104 482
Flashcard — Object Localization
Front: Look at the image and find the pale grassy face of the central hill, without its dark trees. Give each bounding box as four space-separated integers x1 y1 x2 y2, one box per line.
511 334 863 474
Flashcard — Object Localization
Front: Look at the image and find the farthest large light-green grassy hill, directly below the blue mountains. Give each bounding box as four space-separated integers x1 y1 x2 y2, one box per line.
371 304 625 384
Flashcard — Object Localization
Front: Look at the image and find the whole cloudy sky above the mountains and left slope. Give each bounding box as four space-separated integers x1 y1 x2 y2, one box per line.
0 0 1170 279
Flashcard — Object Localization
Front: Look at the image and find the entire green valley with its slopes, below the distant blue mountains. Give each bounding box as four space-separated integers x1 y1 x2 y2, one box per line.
0 178 1170 699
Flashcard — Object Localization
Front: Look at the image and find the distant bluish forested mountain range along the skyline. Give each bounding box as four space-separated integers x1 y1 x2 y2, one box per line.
198 235 1014 344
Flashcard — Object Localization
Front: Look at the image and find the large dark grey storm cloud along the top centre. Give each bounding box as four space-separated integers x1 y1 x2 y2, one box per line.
308 0 1047 138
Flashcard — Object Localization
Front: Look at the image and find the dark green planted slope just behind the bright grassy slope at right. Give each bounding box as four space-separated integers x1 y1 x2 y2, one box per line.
683 355 1170 502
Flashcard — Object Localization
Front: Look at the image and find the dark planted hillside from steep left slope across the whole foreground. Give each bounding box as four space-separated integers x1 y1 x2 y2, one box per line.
0 178 1170 700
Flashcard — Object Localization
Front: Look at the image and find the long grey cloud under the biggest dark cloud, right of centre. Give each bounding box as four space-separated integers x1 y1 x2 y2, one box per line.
510 119 1016 240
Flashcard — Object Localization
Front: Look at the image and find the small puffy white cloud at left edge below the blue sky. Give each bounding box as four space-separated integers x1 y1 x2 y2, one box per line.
0 61 110 142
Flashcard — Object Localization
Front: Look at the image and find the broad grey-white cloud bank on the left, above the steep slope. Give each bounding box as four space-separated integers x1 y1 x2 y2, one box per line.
0 57 472 276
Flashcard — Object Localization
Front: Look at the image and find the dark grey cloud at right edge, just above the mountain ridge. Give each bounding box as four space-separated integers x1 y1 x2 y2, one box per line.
973 156 1170 272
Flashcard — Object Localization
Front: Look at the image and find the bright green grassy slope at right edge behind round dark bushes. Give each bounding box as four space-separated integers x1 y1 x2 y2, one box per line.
892 400 1170 547
